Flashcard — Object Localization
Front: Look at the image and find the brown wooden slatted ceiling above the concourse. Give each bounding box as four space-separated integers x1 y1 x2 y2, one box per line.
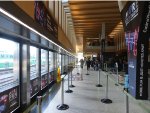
69 1 121 47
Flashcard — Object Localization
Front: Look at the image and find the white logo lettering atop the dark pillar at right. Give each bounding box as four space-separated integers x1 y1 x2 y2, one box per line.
125 1 138 26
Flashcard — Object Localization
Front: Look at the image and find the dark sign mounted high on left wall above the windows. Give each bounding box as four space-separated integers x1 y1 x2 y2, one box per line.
34 1 58 38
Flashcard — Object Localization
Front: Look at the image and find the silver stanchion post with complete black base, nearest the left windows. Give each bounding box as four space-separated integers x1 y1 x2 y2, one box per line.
57 78 69 110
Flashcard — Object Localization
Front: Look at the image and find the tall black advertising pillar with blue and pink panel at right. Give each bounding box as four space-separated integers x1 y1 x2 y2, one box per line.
121 1 150 99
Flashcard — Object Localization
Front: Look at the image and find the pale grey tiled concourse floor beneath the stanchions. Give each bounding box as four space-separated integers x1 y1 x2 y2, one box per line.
37 66 147 113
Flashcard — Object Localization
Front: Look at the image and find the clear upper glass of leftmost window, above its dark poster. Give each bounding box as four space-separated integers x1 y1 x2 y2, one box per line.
0 39 19 92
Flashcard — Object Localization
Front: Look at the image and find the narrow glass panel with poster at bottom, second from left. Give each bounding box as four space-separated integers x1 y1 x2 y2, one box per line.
30 46 39 97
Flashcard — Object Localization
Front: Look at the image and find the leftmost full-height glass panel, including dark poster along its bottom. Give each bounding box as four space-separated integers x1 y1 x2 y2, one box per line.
0 38 19 113
